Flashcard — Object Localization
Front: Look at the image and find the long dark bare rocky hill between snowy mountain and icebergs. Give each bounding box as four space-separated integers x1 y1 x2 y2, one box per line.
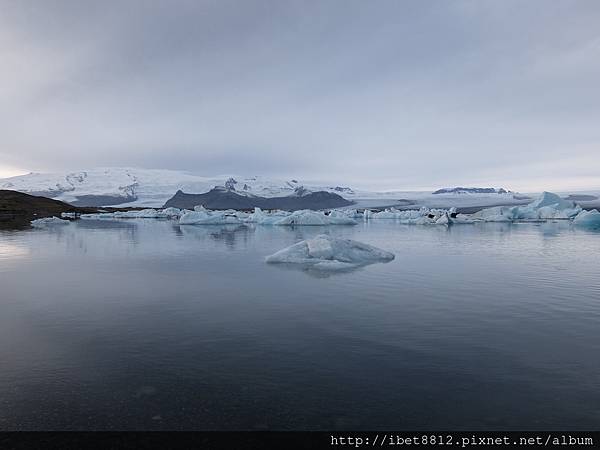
165 188 352 211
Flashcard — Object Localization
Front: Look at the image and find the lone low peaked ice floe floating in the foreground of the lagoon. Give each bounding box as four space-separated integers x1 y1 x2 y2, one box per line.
265 234 394 270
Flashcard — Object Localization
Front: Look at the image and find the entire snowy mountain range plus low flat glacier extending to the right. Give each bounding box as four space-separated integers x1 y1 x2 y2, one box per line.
0 167 568 212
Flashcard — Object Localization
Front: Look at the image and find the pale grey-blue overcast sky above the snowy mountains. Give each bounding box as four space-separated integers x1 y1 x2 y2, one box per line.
0 0 600 191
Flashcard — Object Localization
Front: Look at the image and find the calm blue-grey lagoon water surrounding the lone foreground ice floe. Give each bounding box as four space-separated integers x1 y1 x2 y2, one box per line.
0 220 600 430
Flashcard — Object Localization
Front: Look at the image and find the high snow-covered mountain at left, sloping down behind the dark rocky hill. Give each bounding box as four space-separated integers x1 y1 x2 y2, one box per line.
0 168 356 206
